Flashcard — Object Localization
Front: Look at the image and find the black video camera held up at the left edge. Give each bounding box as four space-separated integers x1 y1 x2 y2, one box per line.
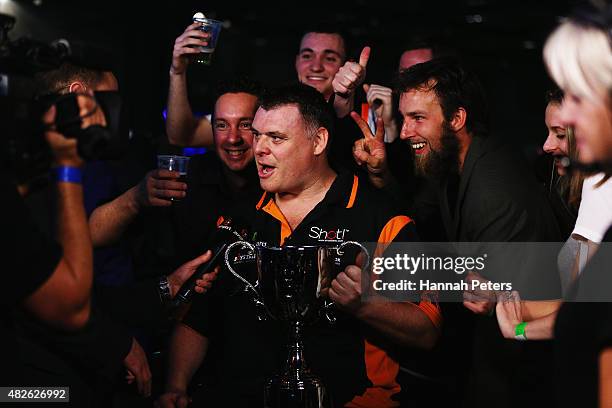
0 13 128 184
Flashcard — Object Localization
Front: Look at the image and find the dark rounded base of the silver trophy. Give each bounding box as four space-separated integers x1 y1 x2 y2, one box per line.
264 373 332 408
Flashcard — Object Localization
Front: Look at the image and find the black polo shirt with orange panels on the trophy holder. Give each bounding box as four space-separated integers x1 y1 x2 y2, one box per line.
183 173 439 407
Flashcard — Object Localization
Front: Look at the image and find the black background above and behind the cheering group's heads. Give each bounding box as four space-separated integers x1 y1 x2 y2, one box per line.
0 0 577 157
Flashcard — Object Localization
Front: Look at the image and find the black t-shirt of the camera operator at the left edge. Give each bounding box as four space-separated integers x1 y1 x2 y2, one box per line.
0 181 62 385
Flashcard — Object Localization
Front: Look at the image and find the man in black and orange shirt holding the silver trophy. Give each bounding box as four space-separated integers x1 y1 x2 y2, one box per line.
159 84 441 407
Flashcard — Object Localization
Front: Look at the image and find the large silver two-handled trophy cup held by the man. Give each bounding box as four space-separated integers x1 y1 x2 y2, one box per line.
225 241 370 408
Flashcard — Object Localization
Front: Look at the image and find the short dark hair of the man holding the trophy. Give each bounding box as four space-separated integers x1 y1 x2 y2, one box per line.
260 82 334 134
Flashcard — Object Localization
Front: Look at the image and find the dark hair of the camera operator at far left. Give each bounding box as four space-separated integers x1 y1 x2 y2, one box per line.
35 62 105 96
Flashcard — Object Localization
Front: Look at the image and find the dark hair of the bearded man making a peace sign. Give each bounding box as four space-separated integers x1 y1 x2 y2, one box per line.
395 58 489 137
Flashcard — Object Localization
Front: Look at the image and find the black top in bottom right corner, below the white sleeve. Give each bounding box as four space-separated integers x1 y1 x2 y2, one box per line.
554 228 612 407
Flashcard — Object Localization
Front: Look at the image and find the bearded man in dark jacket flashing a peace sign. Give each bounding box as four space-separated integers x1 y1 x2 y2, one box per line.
353 59 559 406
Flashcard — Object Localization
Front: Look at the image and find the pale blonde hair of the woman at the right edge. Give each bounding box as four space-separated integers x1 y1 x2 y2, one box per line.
544 20 612 103
